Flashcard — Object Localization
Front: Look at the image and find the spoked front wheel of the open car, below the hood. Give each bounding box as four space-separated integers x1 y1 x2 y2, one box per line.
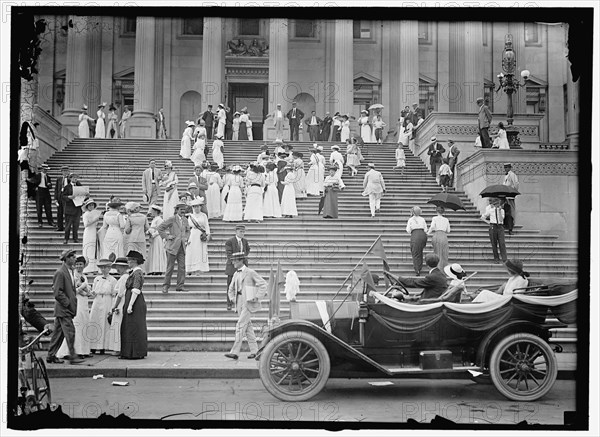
259 331 331 402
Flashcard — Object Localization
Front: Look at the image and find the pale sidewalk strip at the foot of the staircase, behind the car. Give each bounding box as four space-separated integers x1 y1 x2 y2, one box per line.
40 351 577 379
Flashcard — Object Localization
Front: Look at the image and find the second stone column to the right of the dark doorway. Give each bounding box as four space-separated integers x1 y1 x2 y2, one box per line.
333 20 354 114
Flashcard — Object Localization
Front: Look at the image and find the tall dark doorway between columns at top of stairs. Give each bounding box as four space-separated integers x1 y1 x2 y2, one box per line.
227 83 268 140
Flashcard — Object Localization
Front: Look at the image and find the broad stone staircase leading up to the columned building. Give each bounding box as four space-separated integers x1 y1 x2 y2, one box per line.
24 139 577 350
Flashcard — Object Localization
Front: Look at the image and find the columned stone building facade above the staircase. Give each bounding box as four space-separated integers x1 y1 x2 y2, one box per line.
37 16 578 145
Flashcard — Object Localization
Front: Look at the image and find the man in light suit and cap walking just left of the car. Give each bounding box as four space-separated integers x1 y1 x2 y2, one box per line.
225 252 267 360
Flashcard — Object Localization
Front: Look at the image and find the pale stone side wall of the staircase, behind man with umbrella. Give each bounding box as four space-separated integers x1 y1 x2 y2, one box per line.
456 149 579 240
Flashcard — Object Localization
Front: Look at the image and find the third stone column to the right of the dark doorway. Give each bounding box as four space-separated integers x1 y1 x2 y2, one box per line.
397 21 419 109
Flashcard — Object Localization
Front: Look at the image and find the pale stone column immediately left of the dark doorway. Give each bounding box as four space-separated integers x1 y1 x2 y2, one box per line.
200 17 226 108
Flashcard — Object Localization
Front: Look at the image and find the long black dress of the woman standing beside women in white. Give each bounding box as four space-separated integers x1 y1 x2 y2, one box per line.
121 290 148 359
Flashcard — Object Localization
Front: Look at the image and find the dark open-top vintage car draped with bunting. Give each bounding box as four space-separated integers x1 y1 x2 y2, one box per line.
259 282 577 402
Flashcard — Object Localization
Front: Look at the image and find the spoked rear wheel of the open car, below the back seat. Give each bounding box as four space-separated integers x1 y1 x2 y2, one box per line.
489 333 558 401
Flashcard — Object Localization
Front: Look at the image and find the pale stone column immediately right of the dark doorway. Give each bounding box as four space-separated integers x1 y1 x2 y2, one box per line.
268 18 294 113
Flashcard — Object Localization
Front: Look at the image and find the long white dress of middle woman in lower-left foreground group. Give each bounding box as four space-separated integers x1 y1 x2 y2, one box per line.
87 275 117 350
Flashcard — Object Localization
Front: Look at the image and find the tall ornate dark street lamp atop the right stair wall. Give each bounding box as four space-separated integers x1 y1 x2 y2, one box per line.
496 34 529 149
